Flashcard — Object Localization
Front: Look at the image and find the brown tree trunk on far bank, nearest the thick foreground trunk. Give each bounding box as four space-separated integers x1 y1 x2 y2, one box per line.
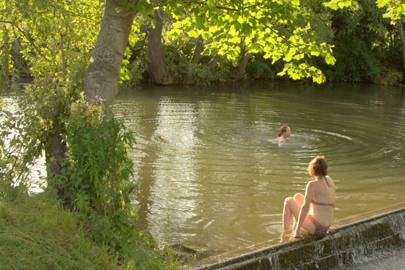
147 10 173 85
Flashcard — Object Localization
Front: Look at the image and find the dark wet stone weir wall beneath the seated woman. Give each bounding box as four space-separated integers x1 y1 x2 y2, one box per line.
193 208 405 270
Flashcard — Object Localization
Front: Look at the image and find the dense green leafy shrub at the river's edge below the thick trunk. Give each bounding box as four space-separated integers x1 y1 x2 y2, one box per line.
56 98 135 255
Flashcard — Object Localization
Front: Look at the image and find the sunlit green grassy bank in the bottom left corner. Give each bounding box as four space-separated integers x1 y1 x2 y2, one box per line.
0 188 175 270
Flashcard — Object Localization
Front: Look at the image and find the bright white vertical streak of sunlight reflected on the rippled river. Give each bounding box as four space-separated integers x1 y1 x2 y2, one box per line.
148 98 199 243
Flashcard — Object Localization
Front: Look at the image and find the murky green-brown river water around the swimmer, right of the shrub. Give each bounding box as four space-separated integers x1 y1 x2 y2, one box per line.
109 83 405 252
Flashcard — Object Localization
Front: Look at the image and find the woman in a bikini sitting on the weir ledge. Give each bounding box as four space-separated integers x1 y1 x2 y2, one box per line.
281 156 336 241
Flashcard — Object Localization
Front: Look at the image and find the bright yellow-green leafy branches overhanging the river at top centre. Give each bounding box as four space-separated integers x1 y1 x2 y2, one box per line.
159 0 353 82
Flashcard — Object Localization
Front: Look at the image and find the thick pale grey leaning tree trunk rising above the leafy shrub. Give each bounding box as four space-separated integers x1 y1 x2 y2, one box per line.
84 0 134 103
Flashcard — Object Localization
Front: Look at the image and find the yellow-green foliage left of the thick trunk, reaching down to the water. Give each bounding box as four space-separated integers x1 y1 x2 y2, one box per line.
0 0 103 192
